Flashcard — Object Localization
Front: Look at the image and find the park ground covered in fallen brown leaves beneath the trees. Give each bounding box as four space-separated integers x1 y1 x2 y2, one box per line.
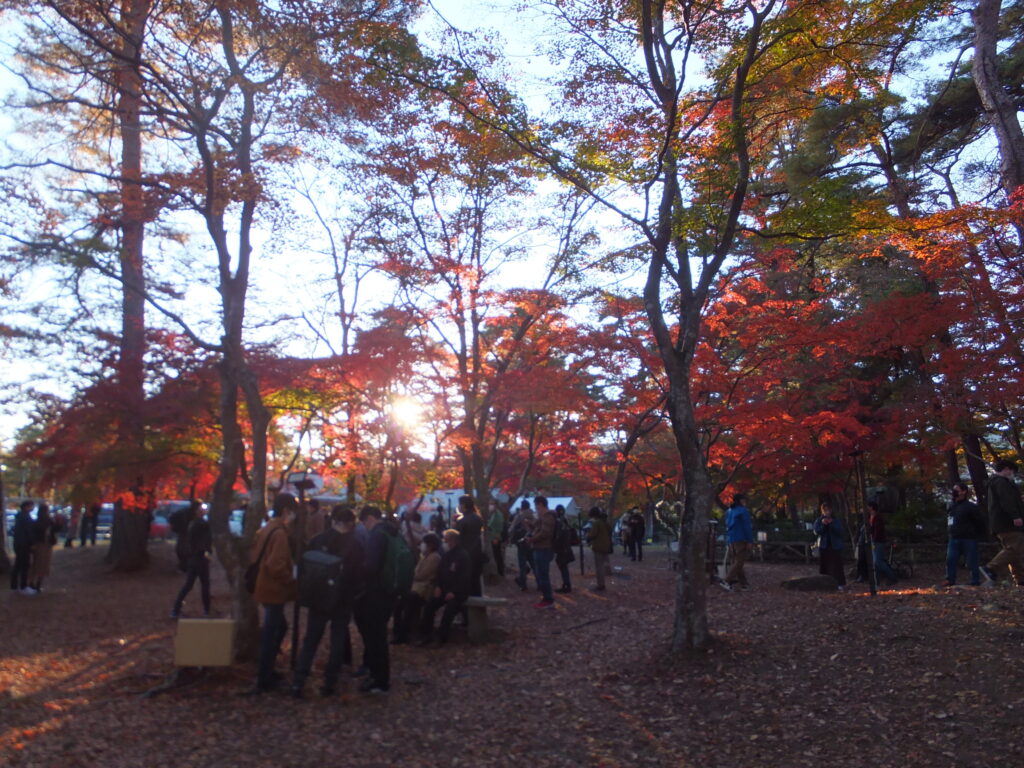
0 543 1024 768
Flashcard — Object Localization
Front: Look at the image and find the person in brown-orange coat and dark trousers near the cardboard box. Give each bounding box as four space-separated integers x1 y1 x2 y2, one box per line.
249 494 299 693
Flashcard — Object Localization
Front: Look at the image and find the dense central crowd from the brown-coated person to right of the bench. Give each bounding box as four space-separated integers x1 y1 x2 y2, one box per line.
238 494 612 698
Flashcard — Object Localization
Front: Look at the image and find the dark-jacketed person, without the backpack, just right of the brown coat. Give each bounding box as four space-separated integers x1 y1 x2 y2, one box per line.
292 506 364 698
